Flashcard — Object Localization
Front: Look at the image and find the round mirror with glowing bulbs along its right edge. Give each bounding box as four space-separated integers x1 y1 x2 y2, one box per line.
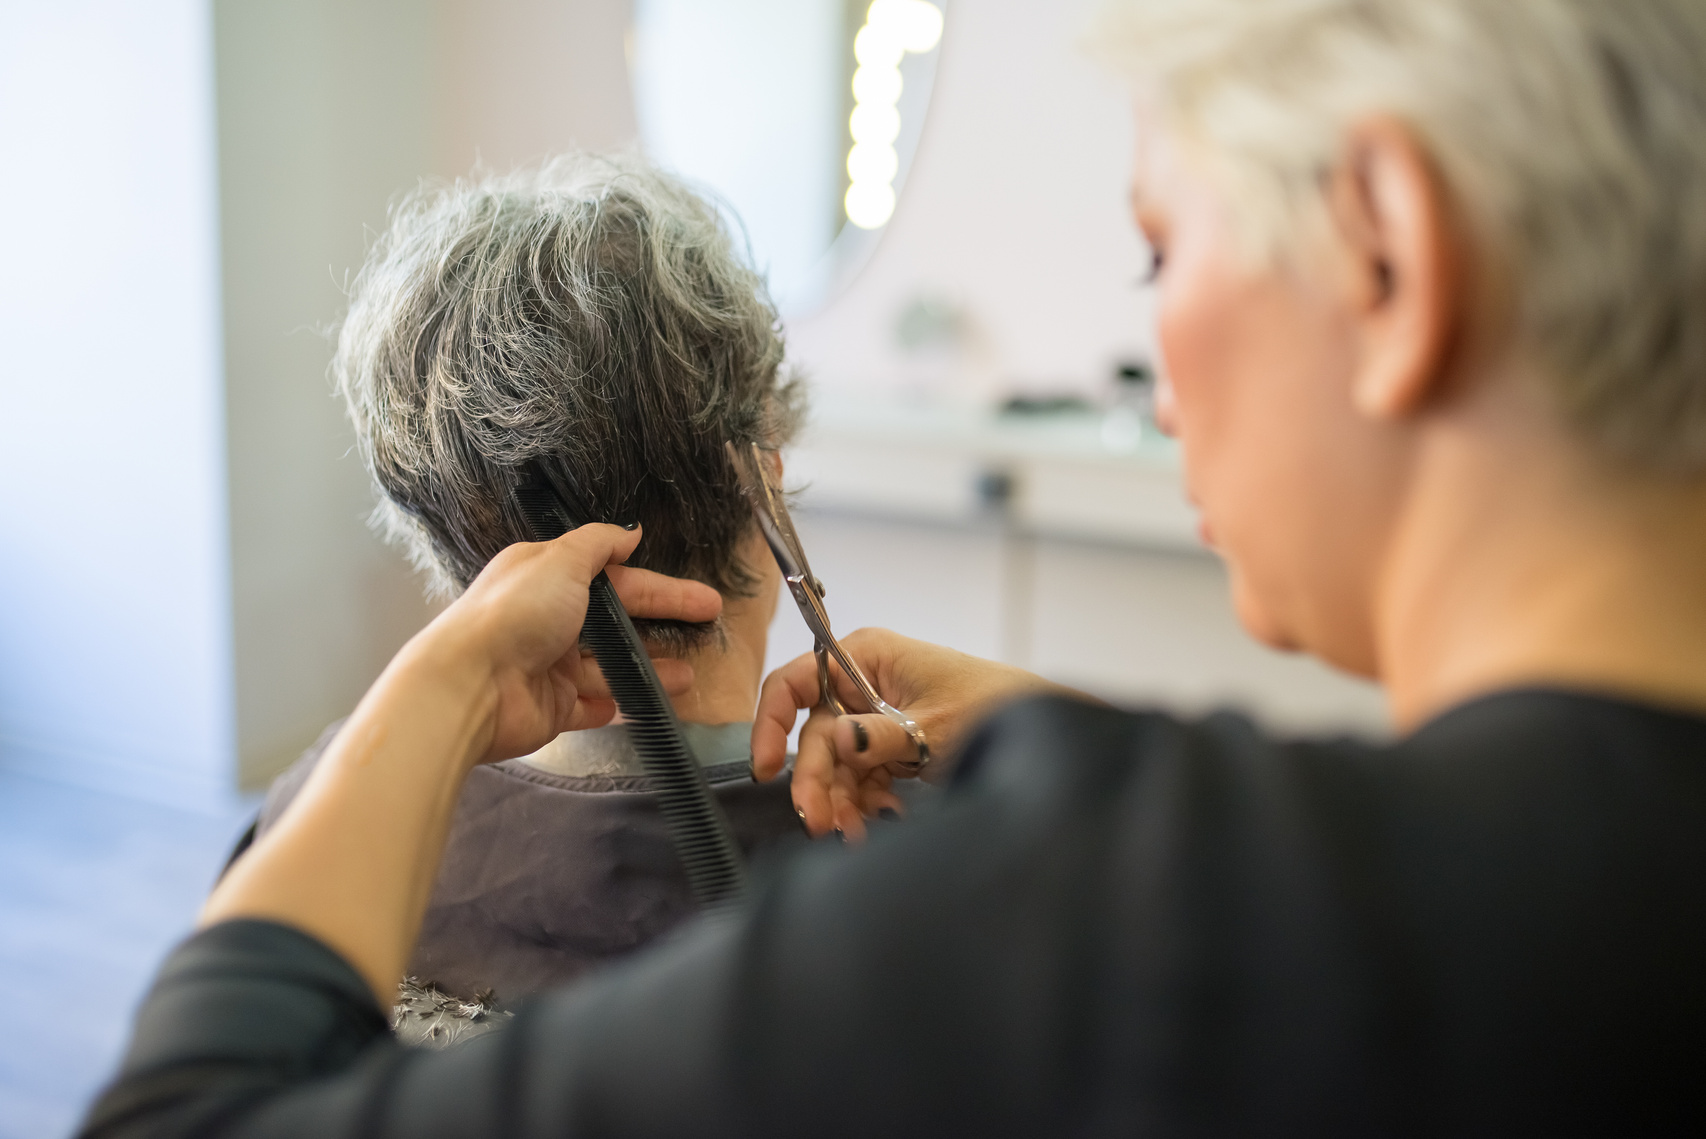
628 0 945 315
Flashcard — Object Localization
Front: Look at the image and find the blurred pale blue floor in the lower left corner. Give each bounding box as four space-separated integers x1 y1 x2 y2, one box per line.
0 772 252 1139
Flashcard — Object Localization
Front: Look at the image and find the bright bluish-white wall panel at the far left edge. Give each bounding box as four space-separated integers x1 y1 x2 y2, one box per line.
0 0 232 805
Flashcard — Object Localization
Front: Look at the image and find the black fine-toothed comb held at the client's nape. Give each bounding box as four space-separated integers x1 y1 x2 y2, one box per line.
515 464 746 911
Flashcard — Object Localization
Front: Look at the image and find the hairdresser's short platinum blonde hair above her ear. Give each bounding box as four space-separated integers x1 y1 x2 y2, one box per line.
1090 0 1706 476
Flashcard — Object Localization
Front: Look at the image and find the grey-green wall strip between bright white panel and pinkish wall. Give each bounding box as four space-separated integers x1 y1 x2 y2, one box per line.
213 0 435 786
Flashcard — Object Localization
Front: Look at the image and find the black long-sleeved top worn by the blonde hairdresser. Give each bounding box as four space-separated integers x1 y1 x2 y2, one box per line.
85 691 1706 1139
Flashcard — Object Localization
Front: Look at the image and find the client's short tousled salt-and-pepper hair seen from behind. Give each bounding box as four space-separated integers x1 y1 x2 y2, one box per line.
333 153 804 610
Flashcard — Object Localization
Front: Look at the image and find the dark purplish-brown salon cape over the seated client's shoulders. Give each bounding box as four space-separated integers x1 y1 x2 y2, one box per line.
258 721 800 1003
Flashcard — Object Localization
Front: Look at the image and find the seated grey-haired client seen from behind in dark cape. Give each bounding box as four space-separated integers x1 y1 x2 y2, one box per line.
259 155 802 1035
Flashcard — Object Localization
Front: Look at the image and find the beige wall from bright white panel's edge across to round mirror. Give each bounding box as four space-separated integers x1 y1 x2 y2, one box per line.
213 0 635 786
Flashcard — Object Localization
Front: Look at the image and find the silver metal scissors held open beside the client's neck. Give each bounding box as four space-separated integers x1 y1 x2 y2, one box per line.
723 443 930 774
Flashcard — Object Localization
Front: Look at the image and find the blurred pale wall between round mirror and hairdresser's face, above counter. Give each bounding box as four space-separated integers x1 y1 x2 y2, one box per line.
788 0 1148 399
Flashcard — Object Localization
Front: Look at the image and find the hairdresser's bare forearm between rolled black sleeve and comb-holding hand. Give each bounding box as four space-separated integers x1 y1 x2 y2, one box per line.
201 636 493 1003
